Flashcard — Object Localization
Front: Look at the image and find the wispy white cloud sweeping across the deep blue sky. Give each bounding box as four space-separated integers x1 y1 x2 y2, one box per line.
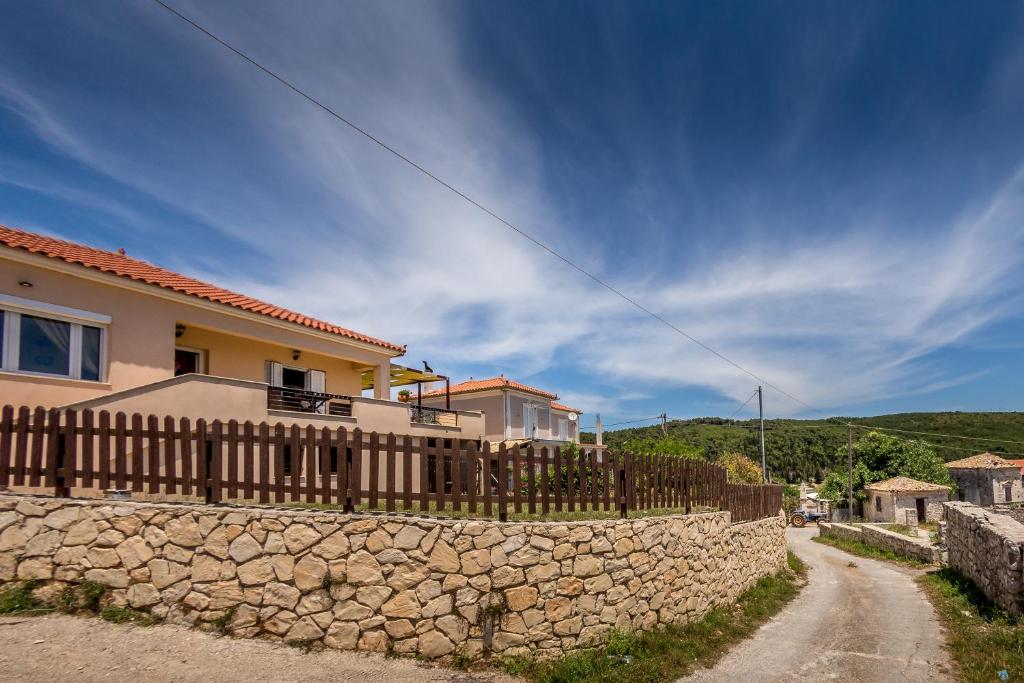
0 4 1024 414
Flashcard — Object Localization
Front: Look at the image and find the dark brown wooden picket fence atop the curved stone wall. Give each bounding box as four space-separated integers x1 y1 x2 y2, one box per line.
0 405 782 522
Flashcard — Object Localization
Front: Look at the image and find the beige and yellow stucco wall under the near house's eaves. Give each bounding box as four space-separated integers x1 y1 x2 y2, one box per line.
0 249 396 407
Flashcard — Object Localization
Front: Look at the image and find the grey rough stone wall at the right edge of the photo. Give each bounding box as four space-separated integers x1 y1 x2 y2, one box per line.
944 502 1024 615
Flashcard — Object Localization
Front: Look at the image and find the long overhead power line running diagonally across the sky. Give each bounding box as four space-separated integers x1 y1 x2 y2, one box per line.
146 0 815 411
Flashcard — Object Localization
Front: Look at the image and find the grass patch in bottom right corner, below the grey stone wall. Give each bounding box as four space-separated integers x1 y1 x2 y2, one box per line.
918 568 1024 683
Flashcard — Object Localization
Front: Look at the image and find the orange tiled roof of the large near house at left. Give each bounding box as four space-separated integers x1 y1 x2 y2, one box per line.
0 225 406 351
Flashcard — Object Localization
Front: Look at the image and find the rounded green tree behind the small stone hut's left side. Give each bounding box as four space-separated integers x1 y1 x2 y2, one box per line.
818 432 953 502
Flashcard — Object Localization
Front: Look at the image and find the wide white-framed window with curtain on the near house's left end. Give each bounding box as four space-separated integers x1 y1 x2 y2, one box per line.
0 295 111 382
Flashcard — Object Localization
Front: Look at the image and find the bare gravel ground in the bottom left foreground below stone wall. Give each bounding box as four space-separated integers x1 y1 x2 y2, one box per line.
0 615 511 683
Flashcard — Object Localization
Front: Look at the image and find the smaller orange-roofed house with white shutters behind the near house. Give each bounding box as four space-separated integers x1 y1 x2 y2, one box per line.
409 375 600 447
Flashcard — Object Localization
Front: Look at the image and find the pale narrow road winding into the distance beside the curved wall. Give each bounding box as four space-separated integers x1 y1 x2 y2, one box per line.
685 526 952 682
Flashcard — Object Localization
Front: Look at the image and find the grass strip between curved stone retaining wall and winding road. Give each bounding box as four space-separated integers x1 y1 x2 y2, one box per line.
504 553 806 683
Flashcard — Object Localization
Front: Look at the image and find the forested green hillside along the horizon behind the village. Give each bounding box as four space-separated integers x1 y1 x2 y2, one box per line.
583 413 1024 481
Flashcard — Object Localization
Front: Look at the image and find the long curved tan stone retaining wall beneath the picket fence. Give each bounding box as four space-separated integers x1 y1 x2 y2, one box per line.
0 495 786 658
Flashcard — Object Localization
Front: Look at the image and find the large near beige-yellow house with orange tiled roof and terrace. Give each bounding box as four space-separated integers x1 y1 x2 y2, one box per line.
0 225 484 439
